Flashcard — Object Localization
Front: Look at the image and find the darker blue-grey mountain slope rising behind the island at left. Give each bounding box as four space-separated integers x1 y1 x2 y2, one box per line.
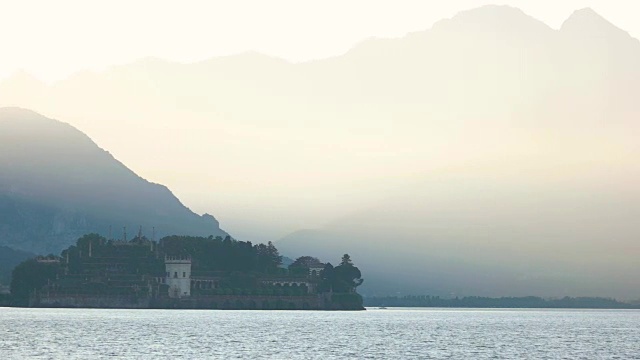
0 108 225 254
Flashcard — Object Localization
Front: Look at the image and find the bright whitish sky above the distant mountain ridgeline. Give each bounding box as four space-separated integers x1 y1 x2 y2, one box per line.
0 0 640 81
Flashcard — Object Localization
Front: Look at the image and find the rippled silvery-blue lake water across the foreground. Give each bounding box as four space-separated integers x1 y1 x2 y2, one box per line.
0 308 640 359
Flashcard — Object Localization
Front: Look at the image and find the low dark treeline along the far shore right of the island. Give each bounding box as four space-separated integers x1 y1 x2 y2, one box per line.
364 295 640 309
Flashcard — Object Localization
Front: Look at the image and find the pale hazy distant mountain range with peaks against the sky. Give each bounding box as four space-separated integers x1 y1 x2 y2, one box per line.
0 6 640 298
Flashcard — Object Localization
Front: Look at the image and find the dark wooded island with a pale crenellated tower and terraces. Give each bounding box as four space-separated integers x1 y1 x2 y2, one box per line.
11 234 364 310
